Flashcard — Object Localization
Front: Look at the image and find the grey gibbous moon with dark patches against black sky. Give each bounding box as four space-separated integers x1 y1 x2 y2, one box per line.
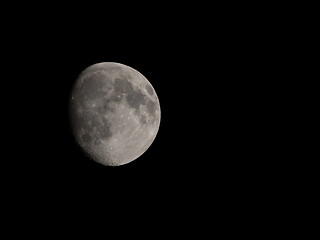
69 62 161 166
